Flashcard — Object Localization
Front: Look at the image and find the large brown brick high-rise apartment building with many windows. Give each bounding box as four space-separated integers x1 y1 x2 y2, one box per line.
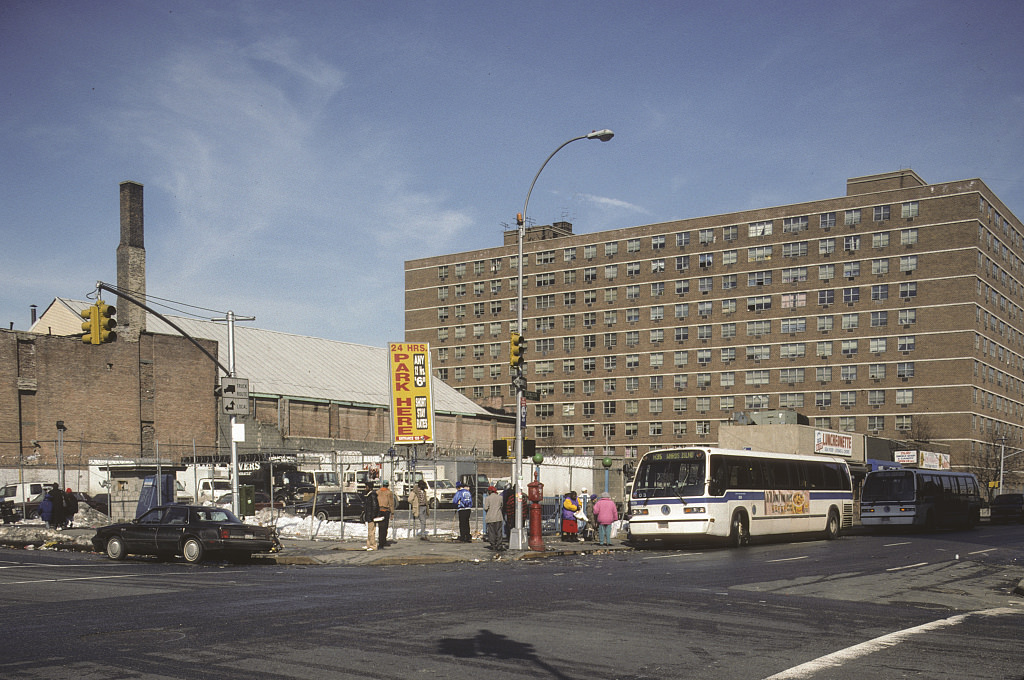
406 170 1024 471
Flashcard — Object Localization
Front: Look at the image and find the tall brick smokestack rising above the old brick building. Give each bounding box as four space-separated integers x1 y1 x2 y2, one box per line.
117 181 145 342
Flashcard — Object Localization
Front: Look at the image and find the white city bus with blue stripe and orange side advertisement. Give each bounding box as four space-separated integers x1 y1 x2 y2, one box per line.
629 447 853 546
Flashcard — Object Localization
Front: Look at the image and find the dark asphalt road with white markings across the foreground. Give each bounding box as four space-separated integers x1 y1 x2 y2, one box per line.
0 525 1024 680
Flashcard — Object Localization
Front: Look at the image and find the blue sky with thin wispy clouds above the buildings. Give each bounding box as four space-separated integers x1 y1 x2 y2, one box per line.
0 0 1024 346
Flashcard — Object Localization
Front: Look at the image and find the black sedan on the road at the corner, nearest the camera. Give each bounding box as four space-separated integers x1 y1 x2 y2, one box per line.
92 505 280 563
